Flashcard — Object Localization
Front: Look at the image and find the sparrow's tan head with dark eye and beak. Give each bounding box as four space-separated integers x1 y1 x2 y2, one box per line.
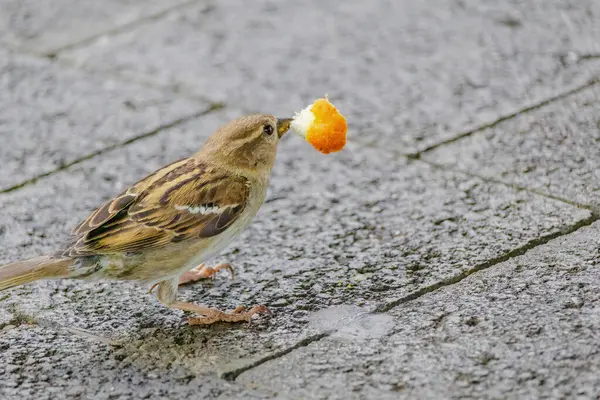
200 114 292 172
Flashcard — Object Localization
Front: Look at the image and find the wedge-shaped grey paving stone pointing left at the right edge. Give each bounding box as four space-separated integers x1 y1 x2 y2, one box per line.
423 85 600 207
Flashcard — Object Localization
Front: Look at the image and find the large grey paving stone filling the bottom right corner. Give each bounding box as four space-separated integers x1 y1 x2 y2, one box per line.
236 222 600 399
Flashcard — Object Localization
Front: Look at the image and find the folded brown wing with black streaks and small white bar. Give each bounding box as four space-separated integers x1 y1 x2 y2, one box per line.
67 159 250 256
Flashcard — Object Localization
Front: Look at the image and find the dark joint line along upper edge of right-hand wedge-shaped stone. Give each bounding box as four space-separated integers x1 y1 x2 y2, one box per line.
405 78 600 159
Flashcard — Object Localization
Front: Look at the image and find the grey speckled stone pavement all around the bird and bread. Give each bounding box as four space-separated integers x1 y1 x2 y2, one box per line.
0 0 600 400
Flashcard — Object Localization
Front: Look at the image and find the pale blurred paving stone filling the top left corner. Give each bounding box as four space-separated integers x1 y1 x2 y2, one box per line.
0 0 191 53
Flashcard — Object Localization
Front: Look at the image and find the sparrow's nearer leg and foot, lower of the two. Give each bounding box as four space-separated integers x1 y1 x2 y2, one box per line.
156 277 270 325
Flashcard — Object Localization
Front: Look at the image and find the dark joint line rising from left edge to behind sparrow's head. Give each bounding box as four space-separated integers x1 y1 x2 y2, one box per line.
0 103 225 194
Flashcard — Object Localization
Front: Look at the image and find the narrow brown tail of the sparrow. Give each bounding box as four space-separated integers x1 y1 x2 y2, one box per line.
0 256 73 291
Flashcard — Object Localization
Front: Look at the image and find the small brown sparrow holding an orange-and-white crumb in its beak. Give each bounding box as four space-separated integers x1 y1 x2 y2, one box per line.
0 115 291 325
